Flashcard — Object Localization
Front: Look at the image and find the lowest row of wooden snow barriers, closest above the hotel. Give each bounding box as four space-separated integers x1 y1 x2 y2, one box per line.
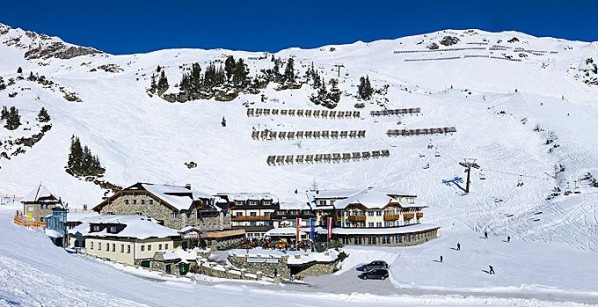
266 149 390 166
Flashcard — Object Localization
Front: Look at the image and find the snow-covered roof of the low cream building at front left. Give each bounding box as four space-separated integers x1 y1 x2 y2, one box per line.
69 215 180 240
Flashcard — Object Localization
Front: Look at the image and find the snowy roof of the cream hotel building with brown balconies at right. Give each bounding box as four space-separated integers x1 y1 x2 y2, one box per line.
334 188 423 209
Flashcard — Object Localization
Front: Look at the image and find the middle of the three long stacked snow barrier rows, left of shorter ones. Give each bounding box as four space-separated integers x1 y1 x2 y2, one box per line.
251 130 365 141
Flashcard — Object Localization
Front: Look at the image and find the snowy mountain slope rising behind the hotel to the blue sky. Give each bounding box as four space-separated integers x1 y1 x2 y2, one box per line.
0 22 598 255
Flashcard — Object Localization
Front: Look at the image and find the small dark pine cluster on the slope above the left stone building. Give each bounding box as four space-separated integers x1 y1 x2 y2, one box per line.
67 135 106 177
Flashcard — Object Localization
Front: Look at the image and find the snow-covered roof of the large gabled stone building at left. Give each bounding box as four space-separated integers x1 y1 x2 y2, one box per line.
141 183 215 210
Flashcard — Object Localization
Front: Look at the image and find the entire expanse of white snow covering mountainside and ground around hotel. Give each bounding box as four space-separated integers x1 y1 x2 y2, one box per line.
0 23 598 305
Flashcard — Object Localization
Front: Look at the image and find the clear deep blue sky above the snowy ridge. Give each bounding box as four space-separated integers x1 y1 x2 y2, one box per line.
0 0 598 54
